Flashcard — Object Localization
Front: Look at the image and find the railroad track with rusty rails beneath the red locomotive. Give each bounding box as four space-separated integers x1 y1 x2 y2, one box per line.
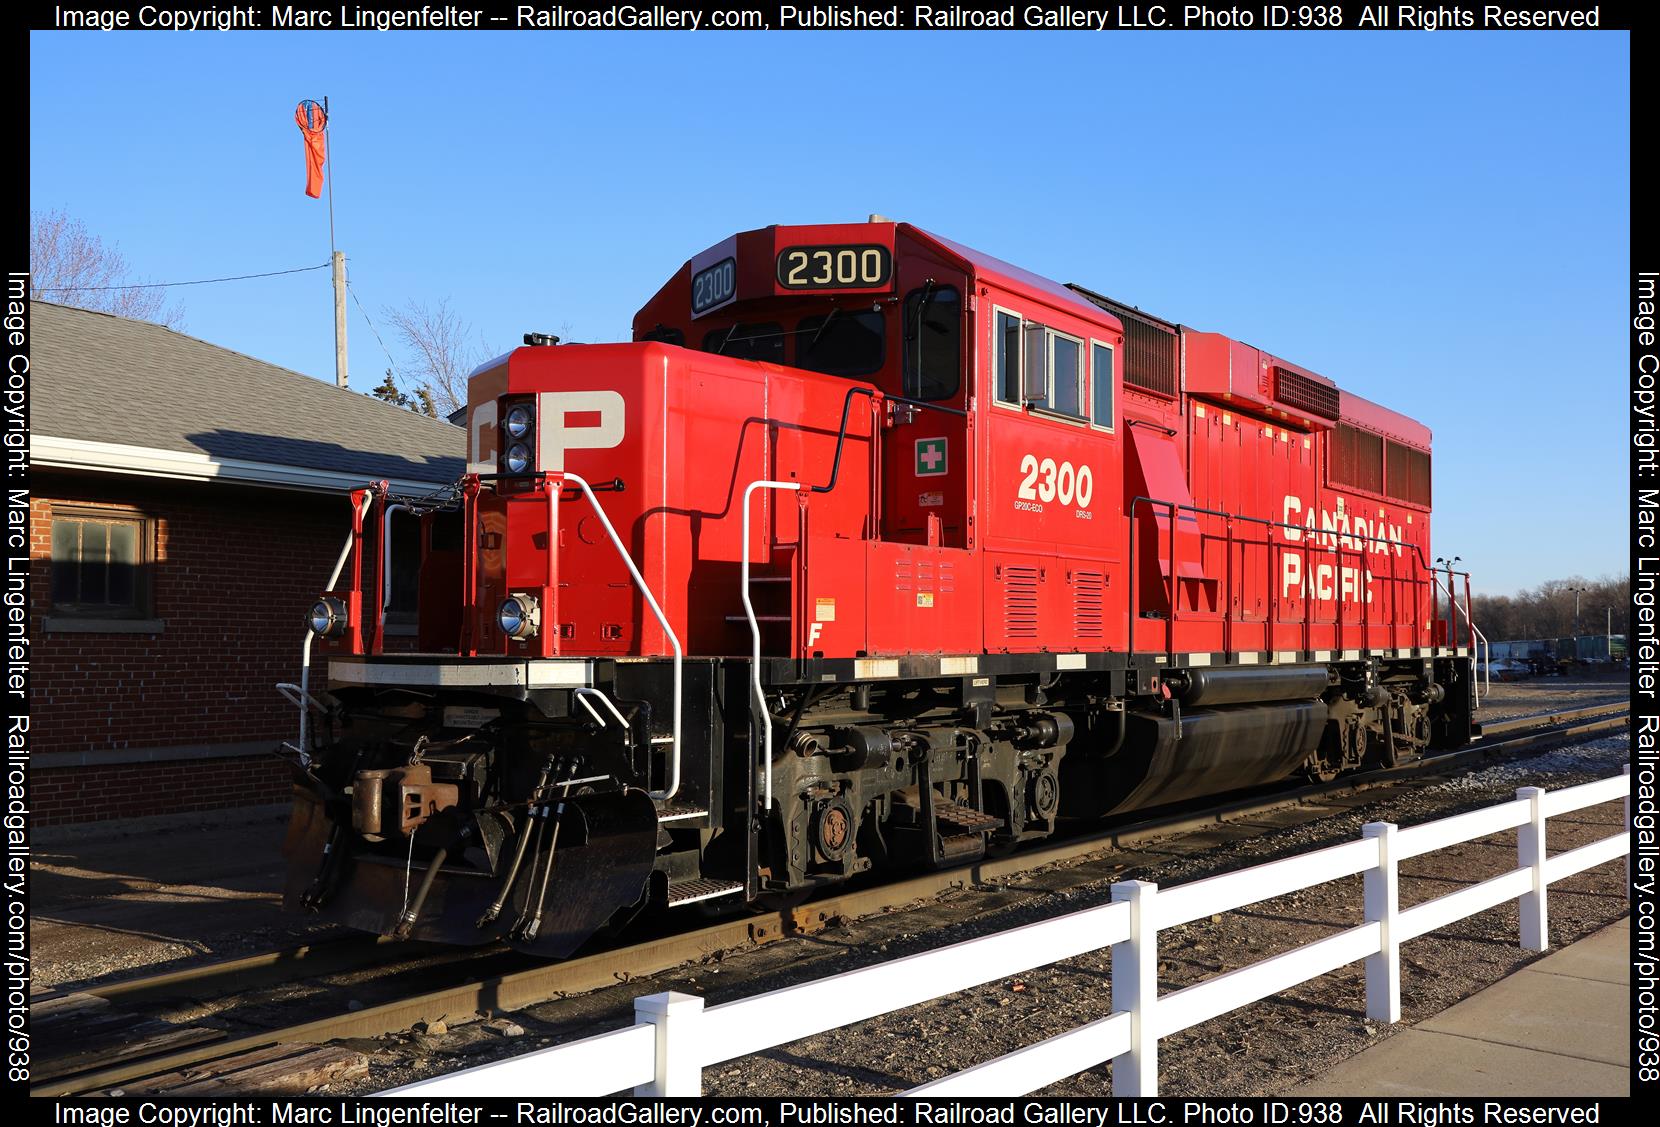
30 702 1630 1095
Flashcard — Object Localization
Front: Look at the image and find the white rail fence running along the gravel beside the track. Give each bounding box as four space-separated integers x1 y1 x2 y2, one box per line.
383 767 1630 1097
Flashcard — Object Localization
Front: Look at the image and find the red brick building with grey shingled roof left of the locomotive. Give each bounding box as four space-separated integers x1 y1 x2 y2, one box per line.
30 302 465 825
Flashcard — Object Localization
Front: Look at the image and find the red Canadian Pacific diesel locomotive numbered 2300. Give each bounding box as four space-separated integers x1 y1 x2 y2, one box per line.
286 217 1476 956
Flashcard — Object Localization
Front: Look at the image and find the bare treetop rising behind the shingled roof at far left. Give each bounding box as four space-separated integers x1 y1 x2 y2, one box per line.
28 211 184 327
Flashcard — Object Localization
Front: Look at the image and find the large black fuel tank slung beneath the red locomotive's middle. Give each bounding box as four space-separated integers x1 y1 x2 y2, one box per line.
1061 700 1326 817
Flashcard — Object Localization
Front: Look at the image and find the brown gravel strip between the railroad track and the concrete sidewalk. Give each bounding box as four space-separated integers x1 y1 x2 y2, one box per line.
343 726 1630 1095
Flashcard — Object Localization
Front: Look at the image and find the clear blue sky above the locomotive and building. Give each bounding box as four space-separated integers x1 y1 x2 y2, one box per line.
30 32 1630 593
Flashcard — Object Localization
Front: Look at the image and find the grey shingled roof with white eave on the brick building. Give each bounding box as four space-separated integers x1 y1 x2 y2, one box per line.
30 300 466 490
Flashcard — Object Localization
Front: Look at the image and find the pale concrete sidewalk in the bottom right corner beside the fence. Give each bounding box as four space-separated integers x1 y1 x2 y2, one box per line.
1287 916 1632 1095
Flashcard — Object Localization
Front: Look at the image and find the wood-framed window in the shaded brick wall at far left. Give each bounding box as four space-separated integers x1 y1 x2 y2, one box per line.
51 506 153 619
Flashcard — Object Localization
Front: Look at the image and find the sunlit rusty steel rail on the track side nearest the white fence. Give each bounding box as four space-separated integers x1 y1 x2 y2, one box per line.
30 702 1630 1095
